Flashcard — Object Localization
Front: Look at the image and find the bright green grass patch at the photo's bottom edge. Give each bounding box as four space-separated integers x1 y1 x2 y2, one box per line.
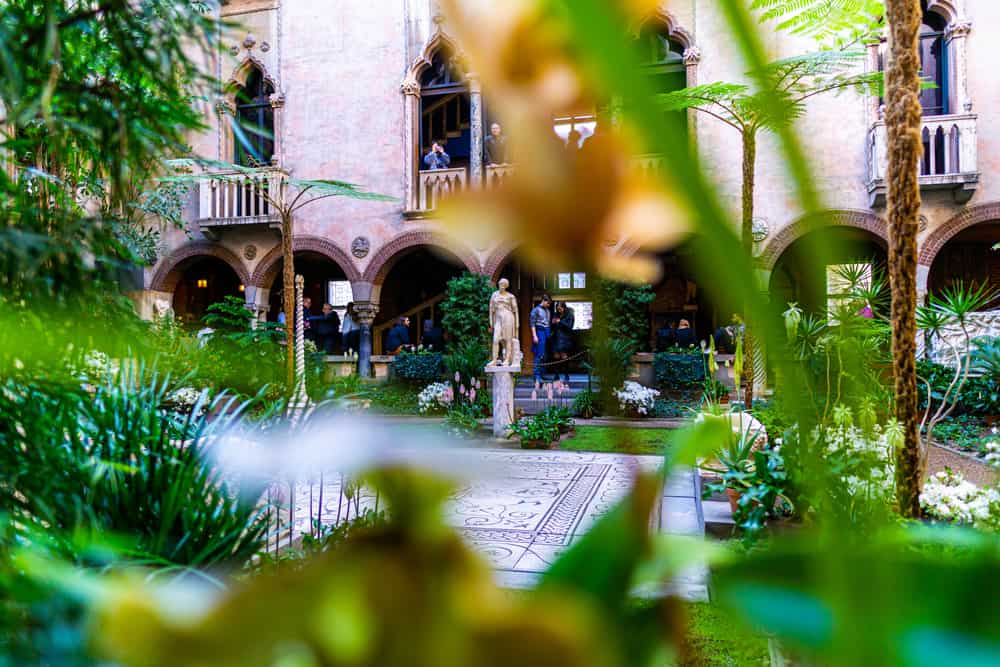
680 602 770 667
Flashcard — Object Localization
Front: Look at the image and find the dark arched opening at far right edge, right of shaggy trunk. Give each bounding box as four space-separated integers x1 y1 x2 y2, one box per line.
928 220 1000 310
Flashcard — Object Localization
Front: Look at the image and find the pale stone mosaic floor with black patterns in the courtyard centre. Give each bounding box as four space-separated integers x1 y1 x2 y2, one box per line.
286 449 708 600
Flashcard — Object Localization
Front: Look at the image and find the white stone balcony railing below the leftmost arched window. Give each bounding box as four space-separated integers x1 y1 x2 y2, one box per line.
198 168 285 227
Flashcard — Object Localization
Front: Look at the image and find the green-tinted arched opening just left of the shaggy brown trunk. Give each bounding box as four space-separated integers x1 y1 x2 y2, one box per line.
770 226 887 316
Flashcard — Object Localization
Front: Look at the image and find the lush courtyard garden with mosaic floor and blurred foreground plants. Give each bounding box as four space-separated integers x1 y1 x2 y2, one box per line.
0 0 1000 667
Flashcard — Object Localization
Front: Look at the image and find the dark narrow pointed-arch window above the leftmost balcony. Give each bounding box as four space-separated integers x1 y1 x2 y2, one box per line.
233 67 274 167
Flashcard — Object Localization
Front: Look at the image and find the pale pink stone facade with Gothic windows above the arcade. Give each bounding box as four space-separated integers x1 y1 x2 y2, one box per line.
137 0 1000 324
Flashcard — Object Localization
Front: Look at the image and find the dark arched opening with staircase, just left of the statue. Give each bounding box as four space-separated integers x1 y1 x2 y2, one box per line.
372 245 467 354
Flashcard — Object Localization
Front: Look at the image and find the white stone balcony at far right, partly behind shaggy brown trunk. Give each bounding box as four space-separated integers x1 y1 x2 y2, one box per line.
868 114 979 207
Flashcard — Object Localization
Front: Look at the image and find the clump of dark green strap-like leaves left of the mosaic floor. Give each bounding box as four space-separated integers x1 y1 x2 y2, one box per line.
0 367 265 567
